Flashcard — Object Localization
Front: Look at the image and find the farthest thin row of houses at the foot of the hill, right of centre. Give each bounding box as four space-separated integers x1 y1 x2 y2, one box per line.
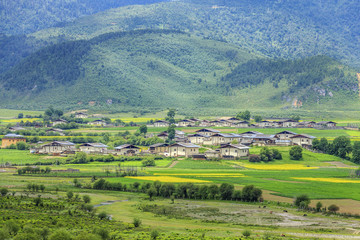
148 118 336 128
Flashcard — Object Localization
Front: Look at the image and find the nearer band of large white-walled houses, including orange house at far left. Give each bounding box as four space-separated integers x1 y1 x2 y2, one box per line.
2 128 315 158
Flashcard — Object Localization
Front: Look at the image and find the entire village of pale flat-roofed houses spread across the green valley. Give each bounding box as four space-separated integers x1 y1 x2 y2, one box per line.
1 113 341 160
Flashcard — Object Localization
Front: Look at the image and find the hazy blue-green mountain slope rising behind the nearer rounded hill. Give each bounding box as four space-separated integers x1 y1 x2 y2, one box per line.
26 0 360 67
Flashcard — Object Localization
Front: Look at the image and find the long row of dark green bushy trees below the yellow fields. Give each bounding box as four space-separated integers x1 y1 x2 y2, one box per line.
88 179 262 202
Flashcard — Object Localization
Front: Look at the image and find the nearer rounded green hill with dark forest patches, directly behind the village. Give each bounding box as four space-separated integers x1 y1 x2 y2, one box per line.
0 30 358 114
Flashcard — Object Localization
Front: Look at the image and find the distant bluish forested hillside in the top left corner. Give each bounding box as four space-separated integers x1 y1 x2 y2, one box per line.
0 0 169 34
